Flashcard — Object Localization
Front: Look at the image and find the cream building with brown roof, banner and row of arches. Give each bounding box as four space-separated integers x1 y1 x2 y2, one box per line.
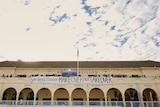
0 61 160 107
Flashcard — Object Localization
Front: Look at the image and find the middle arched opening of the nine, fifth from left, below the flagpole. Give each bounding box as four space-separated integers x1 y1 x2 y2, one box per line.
72 88 87 105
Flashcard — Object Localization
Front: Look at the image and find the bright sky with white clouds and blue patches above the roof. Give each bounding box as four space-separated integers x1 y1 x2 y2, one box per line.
0 0 160 61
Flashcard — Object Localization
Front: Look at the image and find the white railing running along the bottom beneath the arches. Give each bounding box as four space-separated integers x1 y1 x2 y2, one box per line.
0 100 160 107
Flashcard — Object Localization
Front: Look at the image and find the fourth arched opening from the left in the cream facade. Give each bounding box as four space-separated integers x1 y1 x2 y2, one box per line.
54 88 69 105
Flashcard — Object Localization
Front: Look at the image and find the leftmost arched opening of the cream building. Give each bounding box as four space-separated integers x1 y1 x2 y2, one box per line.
2 88 17 100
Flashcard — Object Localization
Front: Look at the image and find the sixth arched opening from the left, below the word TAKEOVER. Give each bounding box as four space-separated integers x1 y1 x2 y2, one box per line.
89 88 105 105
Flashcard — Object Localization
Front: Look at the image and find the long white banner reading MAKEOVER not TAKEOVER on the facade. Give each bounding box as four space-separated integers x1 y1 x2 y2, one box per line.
31 76 112 84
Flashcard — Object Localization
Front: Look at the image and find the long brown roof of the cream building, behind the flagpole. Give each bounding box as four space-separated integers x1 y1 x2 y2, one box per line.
0 61 160 68
